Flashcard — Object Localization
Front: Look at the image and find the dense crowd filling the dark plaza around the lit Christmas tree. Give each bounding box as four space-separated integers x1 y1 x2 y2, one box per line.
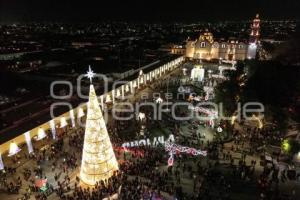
0 67 298 200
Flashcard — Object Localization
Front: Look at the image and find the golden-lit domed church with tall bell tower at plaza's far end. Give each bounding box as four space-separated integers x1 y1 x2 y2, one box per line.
186 15 260 60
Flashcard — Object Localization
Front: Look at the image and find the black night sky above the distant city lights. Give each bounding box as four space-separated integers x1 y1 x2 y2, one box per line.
0 0 300 23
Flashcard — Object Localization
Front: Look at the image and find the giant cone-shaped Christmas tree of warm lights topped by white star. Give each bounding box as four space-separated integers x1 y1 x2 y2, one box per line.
80 68 119 186
